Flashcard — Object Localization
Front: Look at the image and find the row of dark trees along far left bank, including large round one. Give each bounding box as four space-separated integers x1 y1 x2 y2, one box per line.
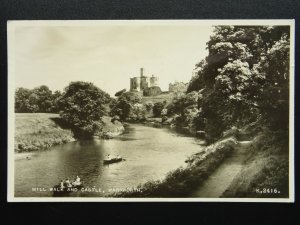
15 81 152 138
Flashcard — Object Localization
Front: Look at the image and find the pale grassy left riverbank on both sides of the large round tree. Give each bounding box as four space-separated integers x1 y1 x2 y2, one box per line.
15 113 125 153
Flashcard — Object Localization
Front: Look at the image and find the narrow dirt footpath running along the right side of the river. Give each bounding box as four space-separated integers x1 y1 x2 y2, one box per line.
191 141 251 198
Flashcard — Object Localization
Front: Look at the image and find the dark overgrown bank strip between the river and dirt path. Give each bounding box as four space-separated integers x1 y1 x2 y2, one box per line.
111 138 236 197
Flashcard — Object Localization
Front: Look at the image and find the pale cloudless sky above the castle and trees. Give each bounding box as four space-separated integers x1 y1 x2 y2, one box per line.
8 23 213 96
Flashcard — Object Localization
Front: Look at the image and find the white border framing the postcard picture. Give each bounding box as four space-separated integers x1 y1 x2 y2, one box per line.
7 19 295 203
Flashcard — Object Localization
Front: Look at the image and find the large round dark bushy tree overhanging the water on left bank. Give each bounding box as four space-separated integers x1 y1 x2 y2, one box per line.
59 81 110 136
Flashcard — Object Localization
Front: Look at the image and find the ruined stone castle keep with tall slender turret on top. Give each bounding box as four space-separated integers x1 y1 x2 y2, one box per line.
130 68 162 96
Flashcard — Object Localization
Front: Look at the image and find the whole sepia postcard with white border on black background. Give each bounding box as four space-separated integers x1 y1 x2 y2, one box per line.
7 20 295 202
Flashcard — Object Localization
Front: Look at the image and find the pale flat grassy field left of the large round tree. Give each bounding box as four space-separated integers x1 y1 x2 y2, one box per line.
15 113 74 152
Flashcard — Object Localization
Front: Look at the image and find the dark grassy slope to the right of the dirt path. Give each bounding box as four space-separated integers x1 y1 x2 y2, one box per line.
222 131 289 198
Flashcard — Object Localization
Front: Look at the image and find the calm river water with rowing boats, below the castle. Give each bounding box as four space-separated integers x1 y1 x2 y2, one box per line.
15 125 202 197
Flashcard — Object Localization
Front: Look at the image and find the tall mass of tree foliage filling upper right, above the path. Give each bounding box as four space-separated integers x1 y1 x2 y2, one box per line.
188 26 290 140
